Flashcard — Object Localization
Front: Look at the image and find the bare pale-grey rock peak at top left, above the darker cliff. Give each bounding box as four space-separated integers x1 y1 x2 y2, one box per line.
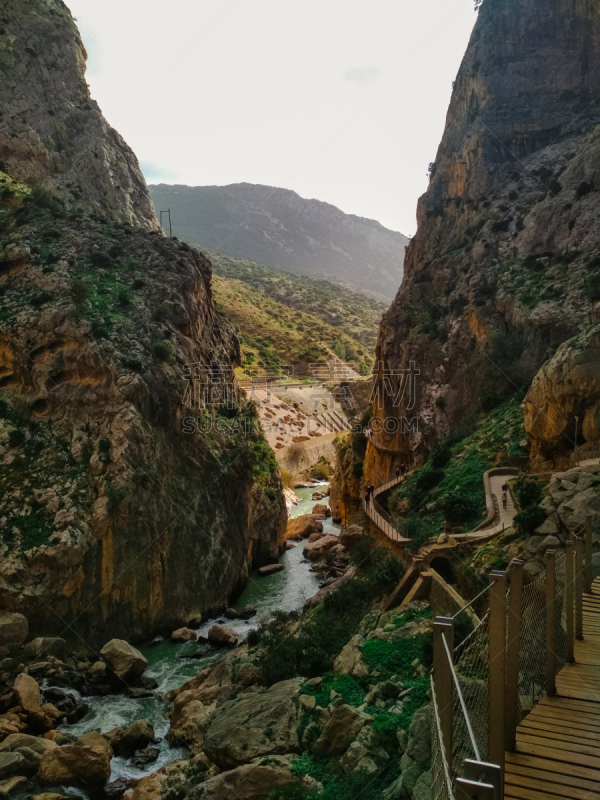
0 0 158 230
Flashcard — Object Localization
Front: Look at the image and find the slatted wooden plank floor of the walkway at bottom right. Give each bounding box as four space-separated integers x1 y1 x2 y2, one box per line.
504 578 600 800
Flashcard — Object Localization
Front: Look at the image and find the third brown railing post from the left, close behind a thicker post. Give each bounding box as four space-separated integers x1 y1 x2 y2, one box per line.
504 559 523 752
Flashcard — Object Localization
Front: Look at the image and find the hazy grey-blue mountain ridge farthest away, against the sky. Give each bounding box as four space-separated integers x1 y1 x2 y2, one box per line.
150 183 408 301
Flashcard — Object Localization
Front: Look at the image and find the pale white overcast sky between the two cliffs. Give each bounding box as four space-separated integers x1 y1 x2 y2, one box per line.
67 0 476 236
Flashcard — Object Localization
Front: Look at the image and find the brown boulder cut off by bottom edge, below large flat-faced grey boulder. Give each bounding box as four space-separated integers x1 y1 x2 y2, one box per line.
188 757 314 800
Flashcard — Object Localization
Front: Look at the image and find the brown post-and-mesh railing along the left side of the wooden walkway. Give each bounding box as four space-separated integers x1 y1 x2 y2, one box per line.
432 517 598 800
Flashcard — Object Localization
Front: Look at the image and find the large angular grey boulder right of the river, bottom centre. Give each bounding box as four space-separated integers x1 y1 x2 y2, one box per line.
203 678 302 769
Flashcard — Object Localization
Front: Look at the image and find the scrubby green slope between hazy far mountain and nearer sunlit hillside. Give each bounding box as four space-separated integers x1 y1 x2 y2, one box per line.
205 251 387 351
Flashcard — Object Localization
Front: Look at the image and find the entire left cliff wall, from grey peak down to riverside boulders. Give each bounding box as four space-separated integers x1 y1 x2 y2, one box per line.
0 0 286 643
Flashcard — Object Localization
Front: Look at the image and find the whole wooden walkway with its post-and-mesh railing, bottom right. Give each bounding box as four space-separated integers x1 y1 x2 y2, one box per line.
431 517 600 800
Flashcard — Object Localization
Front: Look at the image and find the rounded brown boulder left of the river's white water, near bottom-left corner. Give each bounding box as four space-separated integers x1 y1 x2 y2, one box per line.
38 733 112 792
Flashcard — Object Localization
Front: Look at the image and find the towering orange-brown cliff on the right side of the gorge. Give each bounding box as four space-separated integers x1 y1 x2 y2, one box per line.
365 0 600 480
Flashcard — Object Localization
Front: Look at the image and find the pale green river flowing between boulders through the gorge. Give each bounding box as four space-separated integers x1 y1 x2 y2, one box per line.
39 483 339 797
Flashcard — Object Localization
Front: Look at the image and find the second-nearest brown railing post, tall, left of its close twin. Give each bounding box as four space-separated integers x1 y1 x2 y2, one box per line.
488 572 506 774
